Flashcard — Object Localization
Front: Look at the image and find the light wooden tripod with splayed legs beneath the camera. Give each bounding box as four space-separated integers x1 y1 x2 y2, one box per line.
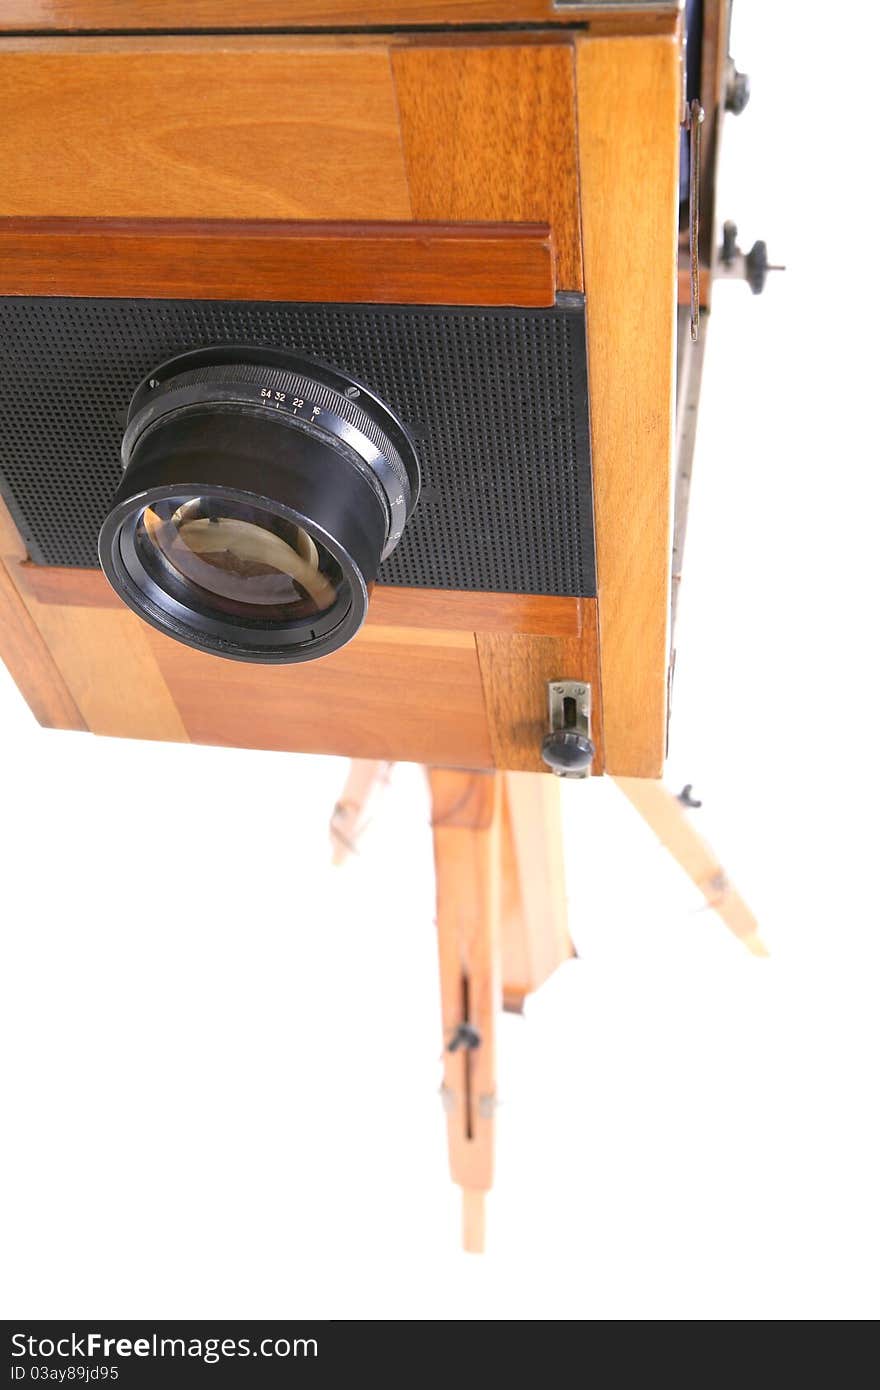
331 762 766 1252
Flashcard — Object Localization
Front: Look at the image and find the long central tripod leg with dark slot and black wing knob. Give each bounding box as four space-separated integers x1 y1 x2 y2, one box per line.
430 770 502 1252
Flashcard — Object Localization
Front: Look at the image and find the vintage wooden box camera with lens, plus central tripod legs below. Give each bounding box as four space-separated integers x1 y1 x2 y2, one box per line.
0 0 756 1244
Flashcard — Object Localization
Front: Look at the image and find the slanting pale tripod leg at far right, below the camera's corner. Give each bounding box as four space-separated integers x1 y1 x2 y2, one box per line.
614 777 767 956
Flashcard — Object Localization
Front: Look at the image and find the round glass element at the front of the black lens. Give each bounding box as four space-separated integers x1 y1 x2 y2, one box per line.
136 496 349 623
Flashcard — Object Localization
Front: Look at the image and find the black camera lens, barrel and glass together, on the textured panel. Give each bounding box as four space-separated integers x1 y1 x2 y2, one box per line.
99 348 418 662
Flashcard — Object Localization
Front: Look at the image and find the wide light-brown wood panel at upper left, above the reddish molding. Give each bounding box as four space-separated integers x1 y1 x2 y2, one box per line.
0 38 412 221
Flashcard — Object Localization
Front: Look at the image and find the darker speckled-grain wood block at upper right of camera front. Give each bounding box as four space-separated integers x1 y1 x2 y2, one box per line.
392 39 584 291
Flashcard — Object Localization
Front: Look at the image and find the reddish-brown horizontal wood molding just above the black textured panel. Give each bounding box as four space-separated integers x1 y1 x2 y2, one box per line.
0 217 556 309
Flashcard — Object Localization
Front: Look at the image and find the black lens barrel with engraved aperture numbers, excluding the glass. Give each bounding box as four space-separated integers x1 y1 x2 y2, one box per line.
99 348 418 663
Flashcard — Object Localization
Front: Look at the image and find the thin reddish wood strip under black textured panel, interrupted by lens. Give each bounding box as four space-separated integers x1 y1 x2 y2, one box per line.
17 562 581 637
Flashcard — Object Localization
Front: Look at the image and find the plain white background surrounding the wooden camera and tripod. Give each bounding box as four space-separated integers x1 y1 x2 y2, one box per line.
0 0 880 1319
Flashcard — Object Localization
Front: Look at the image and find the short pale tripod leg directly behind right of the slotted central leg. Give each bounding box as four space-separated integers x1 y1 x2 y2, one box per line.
499 773 574 1013
